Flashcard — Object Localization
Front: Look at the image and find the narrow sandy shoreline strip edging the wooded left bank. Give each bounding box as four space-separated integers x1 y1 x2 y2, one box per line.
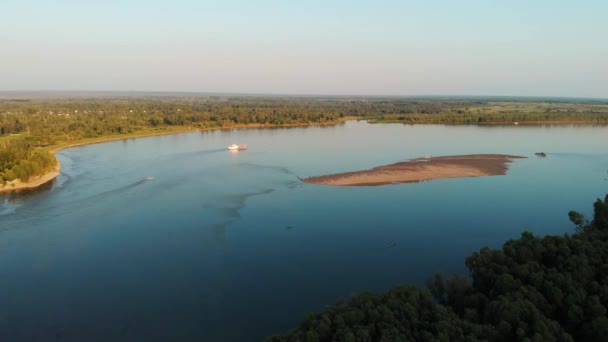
0 117 352 193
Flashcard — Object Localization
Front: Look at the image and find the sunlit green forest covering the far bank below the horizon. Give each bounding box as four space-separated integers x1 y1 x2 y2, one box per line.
0 95 608 185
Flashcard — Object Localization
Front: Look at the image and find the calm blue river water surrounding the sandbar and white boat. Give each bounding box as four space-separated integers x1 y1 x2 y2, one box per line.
0 122 608 341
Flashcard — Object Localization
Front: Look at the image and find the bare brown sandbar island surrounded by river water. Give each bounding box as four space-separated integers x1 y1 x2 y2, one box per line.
301 154 525 186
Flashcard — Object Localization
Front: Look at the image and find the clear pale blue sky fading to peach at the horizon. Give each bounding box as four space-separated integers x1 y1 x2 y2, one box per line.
0 0 608 98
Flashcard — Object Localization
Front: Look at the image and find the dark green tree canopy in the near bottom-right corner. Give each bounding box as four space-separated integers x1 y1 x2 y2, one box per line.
268 195 608 342
